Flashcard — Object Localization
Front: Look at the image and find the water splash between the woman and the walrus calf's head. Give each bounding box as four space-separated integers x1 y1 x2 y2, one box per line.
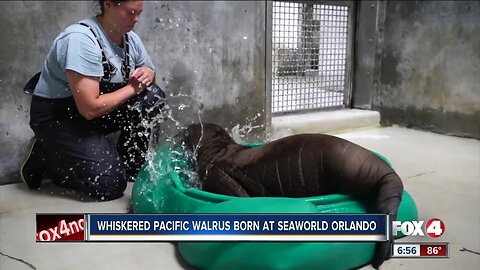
131 89 263 209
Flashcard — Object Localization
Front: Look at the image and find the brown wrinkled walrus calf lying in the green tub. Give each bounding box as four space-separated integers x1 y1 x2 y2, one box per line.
184 123 403 268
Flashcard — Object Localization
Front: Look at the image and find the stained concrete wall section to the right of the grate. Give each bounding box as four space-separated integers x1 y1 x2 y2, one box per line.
372 1 480 138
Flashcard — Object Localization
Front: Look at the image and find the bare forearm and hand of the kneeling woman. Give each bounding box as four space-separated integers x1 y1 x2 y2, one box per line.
67 70 144 120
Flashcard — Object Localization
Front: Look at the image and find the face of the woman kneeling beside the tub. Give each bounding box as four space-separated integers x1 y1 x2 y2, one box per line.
105 1 143 33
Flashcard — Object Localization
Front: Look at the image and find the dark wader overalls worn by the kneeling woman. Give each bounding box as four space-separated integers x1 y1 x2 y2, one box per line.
25 25 165 200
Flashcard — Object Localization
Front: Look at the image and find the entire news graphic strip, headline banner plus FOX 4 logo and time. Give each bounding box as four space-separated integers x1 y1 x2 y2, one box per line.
36 214 449 258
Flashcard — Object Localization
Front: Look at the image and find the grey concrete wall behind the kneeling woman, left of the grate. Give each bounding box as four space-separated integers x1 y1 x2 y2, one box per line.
0 1 266 184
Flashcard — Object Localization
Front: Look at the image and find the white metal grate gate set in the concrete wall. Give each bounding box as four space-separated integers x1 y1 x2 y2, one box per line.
271 1 351 113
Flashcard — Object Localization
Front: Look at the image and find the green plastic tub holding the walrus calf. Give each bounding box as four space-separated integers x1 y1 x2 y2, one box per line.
132 143 418 269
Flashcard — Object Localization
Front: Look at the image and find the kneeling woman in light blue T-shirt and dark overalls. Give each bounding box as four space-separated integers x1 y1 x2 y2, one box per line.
20 0 164 200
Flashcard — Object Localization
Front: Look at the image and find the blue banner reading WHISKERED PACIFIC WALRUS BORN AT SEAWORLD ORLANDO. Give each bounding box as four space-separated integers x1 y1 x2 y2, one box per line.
87 214 388 241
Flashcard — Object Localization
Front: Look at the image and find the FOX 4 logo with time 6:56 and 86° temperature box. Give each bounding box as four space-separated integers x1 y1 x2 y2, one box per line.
392 218 449 258
